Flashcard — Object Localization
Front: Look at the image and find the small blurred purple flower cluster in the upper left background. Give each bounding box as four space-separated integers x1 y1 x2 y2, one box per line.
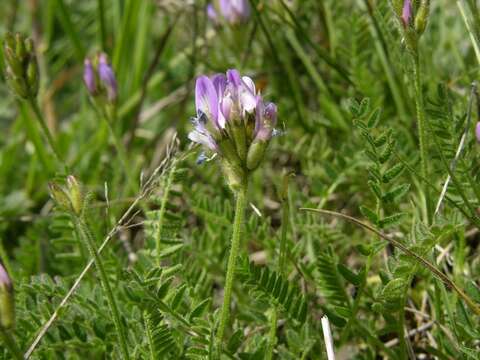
83 53 118 103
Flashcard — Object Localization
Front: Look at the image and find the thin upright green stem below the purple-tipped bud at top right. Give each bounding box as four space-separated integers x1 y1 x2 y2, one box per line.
412 53 432 223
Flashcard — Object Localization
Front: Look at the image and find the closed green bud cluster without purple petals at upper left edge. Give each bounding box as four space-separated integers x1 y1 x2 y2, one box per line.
3 33 39 99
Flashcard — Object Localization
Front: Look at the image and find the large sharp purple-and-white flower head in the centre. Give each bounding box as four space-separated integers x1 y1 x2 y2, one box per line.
189 70 277 187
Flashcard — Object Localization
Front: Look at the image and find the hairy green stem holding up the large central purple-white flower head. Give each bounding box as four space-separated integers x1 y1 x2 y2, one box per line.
217 183 248 350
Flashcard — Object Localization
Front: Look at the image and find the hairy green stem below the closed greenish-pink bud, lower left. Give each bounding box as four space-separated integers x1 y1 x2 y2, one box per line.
74 217 129 360
